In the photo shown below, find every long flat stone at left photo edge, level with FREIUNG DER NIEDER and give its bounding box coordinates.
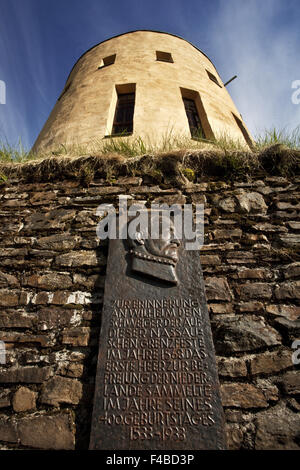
[0,367,51,383]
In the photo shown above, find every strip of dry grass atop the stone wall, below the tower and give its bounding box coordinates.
[0,127,300,186]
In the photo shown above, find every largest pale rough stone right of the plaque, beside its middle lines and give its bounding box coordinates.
[214,317,281,355]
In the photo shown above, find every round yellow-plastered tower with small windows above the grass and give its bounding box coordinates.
[33,31,252,151]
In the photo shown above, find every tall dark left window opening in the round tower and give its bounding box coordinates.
[112,93,135,135]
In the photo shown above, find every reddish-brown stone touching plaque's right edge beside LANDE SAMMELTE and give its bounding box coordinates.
[221,383,268,409]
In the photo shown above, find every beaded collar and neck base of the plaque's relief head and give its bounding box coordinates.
[130,250,178,284]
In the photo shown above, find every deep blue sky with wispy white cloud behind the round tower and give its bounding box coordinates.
[0,0,300,148]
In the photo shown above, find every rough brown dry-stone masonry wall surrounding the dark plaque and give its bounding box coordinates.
[0,172,300,449]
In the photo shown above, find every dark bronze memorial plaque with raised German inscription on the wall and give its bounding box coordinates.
[90,218,225,450]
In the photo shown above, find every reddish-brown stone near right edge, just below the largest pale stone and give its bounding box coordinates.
[249,351,293,375]
